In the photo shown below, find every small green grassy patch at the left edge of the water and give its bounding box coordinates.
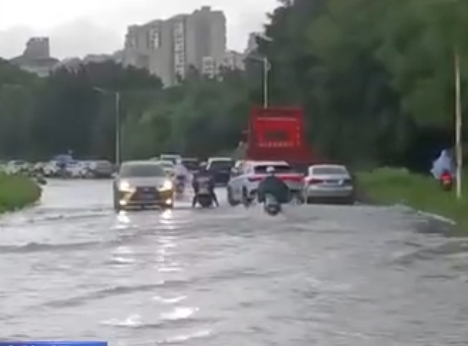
[0,172,42,213]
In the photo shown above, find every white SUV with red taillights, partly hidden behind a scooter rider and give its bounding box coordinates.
[227,161,304,206]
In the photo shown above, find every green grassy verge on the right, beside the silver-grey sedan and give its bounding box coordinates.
[357,168,468,234]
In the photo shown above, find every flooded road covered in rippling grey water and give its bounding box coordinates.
[0,181,468,346]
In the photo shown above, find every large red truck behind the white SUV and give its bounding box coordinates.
[246,107,318,170]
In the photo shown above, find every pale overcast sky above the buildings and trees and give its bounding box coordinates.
[0,0,277,58]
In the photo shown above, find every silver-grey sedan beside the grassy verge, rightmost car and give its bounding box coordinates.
[304,164,355,204]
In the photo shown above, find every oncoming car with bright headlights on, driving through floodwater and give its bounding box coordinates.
[113,161,174,211]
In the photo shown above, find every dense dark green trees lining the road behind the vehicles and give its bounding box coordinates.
[0,0,468,168]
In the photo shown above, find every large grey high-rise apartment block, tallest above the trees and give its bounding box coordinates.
[123,6,226,86]
